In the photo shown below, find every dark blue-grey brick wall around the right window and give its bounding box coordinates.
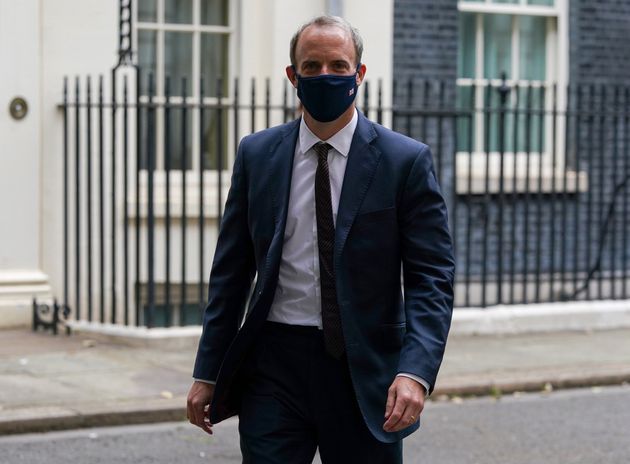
[394,0,630,304]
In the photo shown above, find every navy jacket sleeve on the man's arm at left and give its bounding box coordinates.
[193,139,255,380]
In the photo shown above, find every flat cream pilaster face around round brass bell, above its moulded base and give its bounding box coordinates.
[0,0,41,270]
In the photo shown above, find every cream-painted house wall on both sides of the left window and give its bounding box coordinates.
[0,0,393,326]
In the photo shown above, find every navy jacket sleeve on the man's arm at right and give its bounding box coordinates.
[398,146,455,392]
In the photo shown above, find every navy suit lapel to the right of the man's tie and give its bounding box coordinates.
[335,112,381,259]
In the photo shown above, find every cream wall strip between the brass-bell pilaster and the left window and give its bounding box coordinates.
[38,0,118,324]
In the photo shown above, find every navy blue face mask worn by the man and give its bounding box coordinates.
[293,63,361,122]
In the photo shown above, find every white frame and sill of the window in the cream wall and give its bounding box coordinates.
[127,0,240,220]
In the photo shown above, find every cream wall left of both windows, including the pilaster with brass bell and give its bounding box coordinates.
[0,0,118,326]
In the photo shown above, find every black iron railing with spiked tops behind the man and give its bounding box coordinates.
[62,70,630,327]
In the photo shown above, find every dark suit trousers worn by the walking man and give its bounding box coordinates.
[239,322,402,464]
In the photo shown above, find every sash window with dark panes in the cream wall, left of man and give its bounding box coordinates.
[135,0,234,170]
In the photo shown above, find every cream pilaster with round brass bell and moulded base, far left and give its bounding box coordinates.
[0,0,50,327]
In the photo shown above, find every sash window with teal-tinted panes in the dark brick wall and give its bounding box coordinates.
[457,0,560,153]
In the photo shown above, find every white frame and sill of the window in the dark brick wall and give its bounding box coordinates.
[456,0,587,193]
